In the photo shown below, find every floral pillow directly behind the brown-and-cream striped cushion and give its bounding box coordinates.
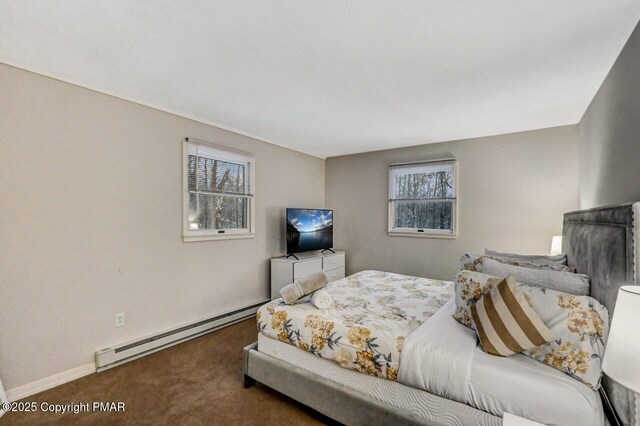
[453,271,609,390]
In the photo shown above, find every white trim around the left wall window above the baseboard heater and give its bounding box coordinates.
[182,138,256,242]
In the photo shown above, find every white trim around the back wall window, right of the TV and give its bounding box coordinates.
[387,158,460,240]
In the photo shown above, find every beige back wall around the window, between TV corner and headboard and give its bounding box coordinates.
[326,126,578,279]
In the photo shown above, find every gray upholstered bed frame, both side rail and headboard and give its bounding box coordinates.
[244,203,640,426]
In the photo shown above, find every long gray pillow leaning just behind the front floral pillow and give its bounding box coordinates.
[476,257,589,296]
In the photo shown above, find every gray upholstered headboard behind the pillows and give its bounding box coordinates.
[562,203,640,425]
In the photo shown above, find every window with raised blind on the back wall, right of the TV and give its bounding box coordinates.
[389,160,457,237]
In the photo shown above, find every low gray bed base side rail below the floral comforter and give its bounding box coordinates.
[244,342,502,426]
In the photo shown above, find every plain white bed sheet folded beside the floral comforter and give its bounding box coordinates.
[398,300,604,426]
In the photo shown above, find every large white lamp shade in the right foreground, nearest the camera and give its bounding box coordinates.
[602,285,640,392]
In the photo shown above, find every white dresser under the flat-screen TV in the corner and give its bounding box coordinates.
[271,250,344,300]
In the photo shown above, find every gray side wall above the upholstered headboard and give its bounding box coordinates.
[579,20,640,208]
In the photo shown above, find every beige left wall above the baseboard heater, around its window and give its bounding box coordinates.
[0,64,325,389]
